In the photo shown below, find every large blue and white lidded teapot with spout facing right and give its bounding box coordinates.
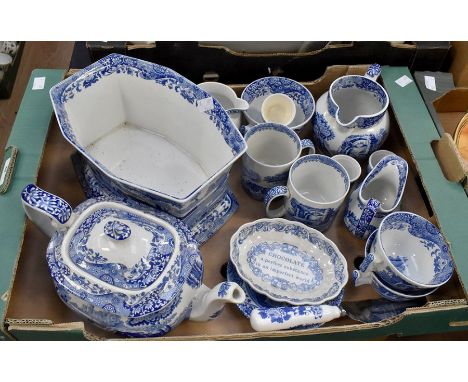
[21,184,245,336]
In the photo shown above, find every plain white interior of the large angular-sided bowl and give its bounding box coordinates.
[64,72,234,198]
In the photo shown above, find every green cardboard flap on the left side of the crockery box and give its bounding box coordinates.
[0,69,65,338]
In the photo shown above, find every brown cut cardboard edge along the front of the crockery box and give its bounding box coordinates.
[6,299,467,341]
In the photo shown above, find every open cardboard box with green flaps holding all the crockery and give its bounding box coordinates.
[0,66,468,340]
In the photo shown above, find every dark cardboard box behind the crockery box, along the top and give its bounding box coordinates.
[83,41,451,84]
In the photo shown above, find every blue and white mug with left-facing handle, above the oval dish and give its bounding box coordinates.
[264,154,350,231]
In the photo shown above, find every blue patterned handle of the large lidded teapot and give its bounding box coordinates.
[21,184,74,237]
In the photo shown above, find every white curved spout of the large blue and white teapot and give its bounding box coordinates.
[189,282,245,321]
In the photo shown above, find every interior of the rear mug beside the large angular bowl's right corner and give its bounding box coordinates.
[246,124,301,166]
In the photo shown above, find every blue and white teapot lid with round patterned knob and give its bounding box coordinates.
[61,202,180,290]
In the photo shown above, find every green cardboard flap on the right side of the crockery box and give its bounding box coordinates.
[382,66,468,296]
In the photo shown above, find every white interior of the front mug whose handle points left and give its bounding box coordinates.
[290,155,349,203]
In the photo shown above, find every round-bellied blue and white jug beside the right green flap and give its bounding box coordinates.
[312,64,390,159]
